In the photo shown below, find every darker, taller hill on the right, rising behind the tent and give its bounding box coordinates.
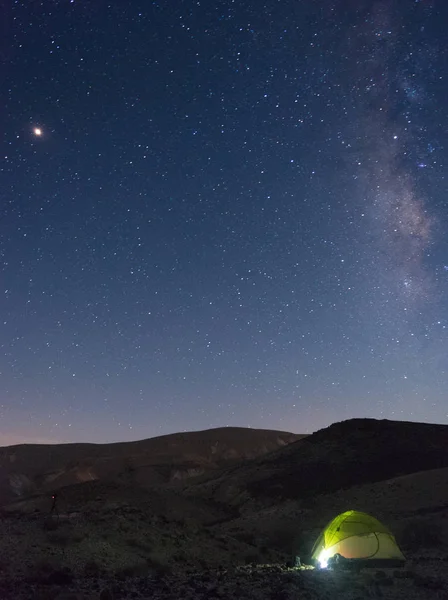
[190,419,448,505]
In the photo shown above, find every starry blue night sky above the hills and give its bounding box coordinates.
[0,0,448,444]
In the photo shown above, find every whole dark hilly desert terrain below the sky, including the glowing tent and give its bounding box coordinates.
[0,419,448,600]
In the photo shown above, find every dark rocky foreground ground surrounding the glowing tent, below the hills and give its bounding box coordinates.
[0,489,448,600]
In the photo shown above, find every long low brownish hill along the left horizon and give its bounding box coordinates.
[0,427,302,504]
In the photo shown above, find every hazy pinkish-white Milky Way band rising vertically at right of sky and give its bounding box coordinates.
[344,2,437,316]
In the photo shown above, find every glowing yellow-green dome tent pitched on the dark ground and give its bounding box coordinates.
[311,510,405,568]
